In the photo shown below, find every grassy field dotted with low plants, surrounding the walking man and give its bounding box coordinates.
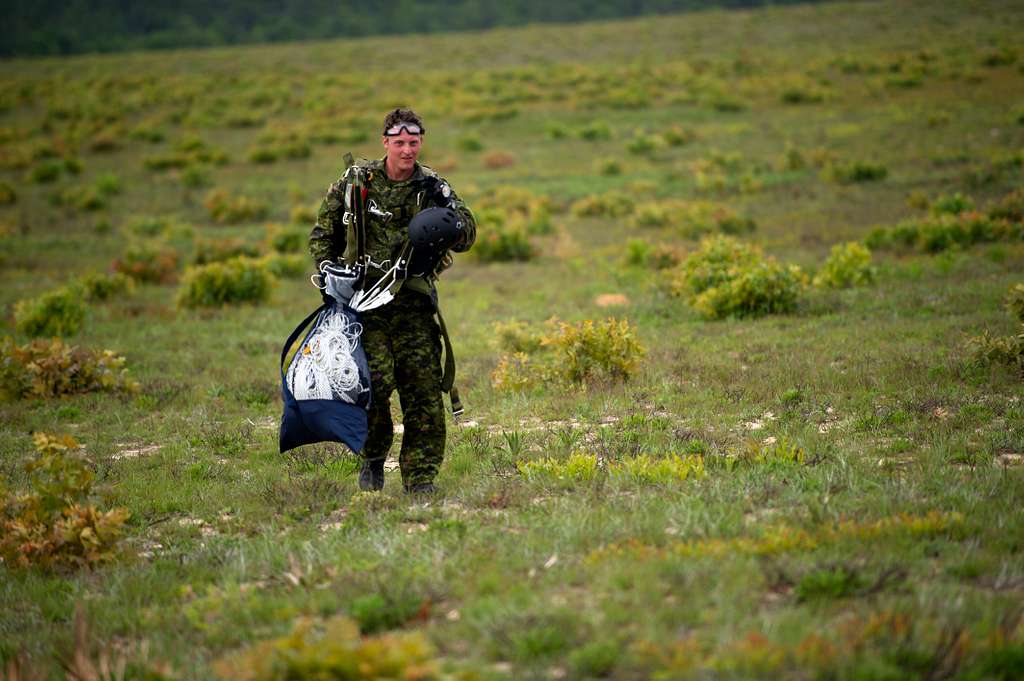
[0,1,1024,679]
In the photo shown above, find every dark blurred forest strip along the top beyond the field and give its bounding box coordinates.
[0,0,823,57]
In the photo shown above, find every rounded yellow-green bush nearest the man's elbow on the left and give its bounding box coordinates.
[177,258,271,307]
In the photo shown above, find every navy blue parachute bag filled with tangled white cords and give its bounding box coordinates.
[281,300,371,452]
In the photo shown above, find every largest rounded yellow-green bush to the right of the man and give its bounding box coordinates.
[667,237,807,320]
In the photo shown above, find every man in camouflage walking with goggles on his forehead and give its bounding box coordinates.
[309,109,476,494]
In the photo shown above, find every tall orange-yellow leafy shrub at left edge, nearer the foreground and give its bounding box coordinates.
[0,432,129,568]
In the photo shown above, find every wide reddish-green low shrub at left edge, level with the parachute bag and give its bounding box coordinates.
[0,337,138,399]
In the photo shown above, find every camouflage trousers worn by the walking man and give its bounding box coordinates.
[361,290,444,488]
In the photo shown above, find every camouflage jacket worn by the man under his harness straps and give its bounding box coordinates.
[309,159,476,293]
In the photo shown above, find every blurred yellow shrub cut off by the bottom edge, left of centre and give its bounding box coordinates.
[213,616,449,681]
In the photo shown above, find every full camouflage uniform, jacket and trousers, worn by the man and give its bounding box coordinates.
[309,159,476,488]
